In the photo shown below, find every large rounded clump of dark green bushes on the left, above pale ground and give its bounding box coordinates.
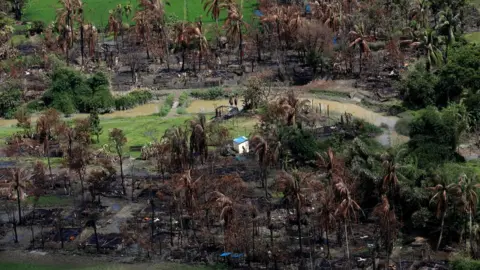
[43,68,115,114]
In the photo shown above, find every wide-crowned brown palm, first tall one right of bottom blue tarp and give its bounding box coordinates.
[275,171,311,254]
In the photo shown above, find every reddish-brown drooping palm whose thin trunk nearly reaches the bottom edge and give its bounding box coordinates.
[335,180,361,264]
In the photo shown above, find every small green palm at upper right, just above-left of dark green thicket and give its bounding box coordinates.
[410,29,442,71]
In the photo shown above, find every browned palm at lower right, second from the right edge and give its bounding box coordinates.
[427,177,458,250]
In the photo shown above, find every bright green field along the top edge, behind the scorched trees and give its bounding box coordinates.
[24,0,257,27]
